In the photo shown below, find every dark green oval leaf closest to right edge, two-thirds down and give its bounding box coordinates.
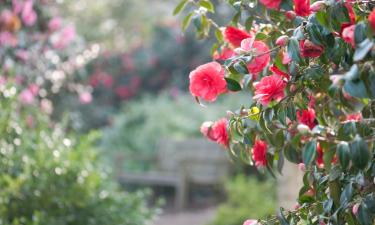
[350,135,370,170]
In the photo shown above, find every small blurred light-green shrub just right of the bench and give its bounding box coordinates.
[209,175,276,225]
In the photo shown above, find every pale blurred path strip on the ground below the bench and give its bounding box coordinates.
[154,208,216,225]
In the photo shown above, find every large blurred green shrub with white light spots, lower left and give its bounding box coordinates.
[0,87,153,225]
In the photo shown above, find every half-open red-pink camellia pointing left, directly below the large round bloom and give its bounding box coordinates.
[201,118,229,147]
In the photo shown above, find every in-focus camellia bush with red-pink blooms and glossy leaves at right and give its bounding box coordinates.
[174,0,375,225]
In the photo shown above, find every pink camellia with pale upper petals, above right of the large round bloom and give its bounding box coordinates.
[241,38,271,74]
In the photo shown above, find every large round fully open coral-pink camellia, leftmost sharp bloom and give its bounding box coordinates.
[189,62,227,102]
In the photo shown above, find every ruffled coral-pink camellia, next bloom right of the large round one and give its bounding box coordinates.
[253,75,286,105]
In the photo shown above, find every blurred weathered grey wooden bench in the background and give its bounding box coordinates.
[117,139,230,210]
